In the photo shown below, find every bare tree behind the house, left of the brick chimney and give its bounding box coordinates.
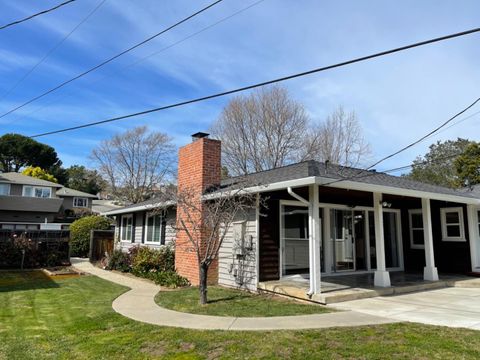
[92,126,175,203]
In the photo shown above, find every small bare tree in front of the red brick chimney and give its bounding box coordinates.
[175,184,260,305]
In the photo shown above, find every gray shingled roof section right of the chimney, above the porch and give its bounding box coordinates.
[222,160,479,199]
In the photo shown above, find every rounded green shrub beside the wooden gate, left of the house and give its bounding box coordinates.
[70,215,110,257]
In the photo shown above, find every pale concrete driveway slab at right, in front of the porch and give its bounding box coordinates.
[331,287,480,330]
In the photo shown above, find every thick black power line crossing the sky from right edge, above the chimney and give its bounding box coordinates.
[28,28,480,138]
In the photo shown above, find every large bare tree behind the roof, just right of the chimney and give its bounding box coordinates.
[211,87,309,175]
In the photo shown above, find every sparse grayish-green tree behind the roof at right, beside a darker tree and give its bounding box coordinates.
[407,138,474,188]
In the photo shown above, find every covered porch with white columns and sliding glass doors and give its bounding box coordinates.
[257,178,480,303]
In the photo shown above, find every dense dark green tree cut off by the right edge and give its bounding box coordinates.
[454,143,480,187]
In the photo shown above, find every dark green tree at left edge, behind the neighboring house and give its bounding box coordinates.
[0,134,62,172]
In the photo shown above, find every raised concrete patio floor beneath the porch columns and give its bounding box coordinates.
[258,271,480,304]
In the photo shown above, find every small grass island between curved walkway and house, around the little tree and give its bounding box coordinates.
[155,286,331,317]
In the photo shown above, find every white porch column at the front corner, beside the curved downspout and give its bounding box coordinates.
[308,185,322,295]
